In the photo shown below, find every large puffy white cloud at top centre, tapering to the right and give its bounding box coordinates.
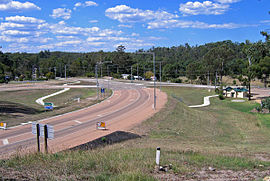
[105,5,178,23]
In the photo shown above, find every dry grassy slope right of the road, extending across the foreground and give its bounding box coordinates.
[0,88,270,180]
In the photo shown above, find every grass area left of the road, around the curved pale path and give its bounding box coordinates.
[0,88,97,127]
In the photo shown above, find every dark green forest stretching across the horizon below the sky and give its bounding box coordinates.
[0,32,270,86]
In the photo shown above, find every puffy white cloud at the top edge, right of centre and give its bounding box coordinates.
[179,1,230,15]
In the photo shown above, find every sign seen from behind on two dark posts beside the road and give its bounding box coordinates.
[32,122,54,153]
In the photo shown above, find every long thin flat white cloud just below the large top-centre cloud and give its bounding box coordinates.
[147,19,248,29]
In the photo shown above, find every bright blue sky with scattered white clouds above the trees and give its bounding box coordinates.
[0,0,270,52]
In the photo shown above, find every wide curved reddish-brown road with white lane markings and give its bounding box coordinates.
[0,80,167,157]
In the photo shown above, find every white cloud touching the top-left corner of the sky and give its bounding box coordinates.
[0,0,41,11]
